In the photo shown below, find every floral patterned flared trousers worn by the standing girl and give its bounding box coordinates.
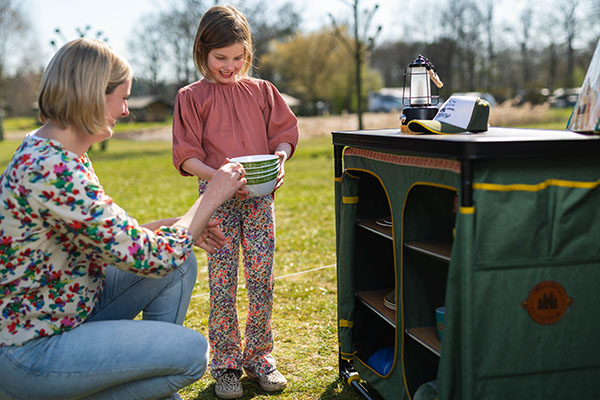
[200,182,275,378]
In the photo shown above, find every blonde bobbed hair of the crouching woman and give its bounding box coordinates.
[38,38,133,134]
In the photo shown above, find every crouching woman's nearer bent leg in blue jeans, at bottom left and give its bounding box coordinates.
[0,320,208,400]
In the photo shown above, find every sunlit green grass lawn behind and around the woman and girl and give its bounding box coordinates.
[0,114,580,400]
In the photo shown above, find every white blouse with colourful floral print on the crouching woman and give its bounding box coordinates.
[0,135,193,346]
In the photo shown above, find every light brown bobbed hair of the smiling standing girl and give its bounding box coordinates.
[194,6,254,77]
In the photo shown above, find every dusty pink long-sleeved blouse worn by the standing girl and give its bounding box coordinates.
[173,77,298,176]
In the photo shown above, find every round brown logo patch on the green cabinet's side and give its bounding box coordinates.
[521,281,573,325]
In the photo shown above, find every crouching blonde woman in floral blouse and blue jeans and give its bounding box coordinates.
[0,39,245,399]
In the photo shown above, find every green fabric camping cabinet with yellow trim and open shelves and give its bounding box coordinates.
[332,128,600,400]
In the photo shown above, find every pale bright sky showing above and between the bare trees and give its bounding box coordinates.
[23,0,580,72]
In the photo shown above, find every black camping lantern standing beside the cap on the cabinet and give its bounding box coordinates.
[401,54,441,125]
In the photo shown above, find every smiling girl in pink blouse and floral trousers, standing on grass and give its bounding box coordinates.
[173,6,298,398]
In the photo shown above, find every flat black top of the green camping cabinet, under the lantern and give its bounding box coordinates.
[332,127,600,160]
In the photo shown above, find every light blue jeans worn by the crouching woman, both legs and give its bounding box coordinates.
[0,253,208,400]
